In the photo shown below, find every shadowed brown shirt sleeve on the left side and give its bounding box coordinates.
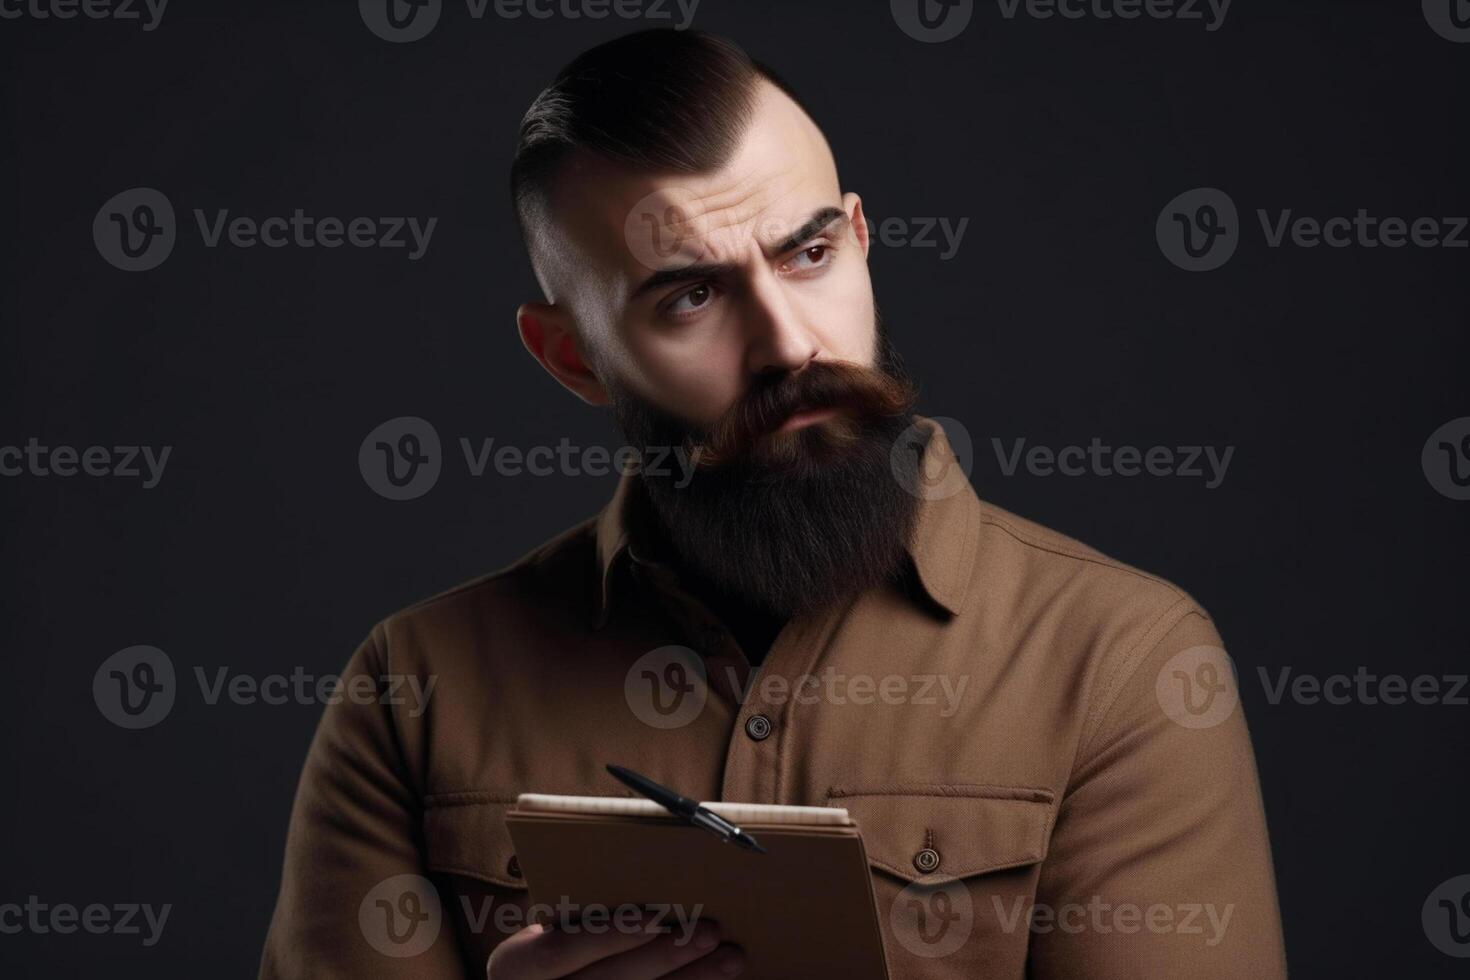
[260,627,466,980]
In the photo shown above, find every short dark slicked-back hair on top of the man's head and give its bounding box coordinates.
[510,28,801,264]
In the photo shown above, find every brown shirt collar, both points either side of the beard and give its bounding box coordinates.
[595,416,980,627]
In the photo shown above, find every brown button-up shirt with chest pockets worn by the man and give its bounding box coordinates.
[260,423,1285,980]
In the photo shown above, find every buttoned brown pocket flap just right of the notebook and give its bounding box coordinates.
[828,786,1054,883]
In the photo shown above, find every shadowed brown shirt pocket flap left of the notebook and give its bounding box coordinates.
[423,793,526,889]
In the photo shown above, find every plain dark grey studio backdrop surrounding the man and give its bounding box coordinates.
[0,0,1470,977]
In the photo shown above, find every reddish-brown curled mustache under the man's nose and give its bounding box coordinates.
[689,361,917,466]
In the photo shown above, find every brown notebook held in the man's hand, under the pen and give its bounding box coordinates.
[506,793,888,980]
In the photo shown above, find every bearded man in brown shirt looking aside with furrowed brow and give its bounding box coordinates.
[262,31,1285,980]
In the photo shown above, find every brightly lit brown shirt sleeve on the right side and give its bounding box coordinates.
[1029,601,1286,980]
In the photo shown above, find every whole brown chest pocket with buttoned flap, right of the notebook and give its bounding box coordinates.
[828,785,1055,980]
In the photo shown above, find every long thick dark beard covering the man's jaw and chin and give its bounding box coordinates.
[609,322,919,619]
